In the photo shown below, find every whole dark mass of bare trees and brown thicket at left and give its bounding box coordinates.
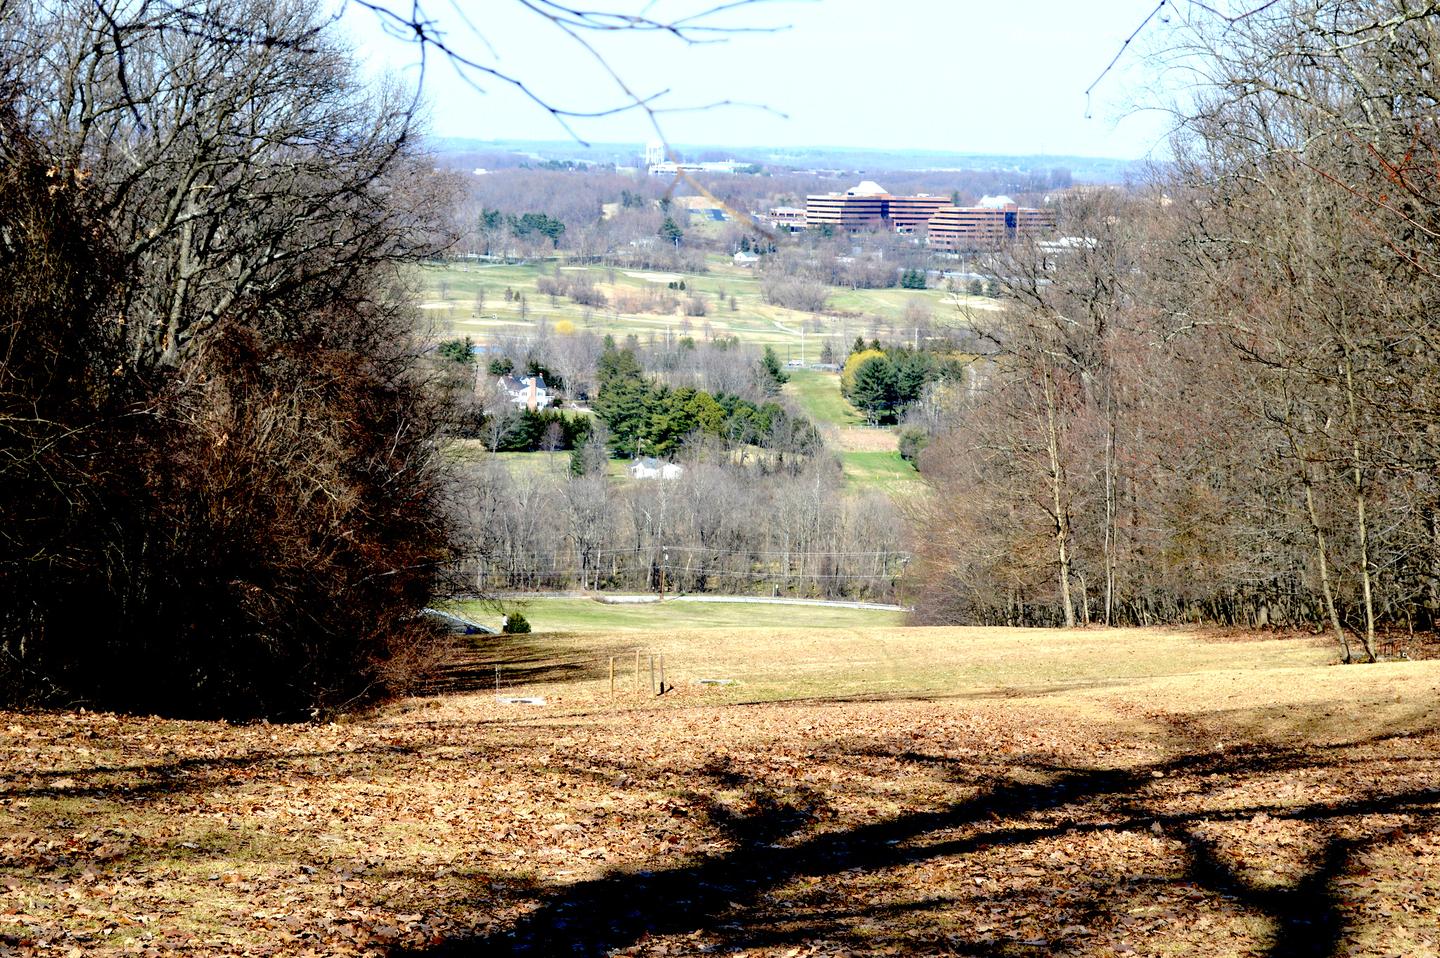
[0,0,448,716]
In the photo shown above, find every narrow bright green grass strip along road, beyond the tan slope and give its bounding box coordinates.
[454,598,904,632]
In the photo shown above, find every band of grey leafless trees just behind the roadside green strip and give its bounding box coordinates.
[458,455,906,601]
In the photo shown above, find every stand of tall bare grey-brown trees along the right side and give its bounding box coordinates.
[924,0,1440,660]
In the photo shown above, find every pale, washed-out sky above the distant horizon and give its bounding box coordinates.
[347,0,1166,158]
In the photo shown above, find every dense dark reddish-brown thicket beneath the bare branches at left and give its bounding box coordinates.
[0,29,449,719]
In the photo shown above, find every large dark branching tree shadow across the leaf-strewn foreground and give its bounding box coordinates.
[392,751,1440,958]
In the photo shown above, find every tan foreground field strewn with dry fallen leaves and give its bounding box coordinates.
[0,628,1440,958]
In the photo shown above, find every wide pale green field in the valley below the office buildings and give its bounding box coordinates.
[418,256,991,351]
